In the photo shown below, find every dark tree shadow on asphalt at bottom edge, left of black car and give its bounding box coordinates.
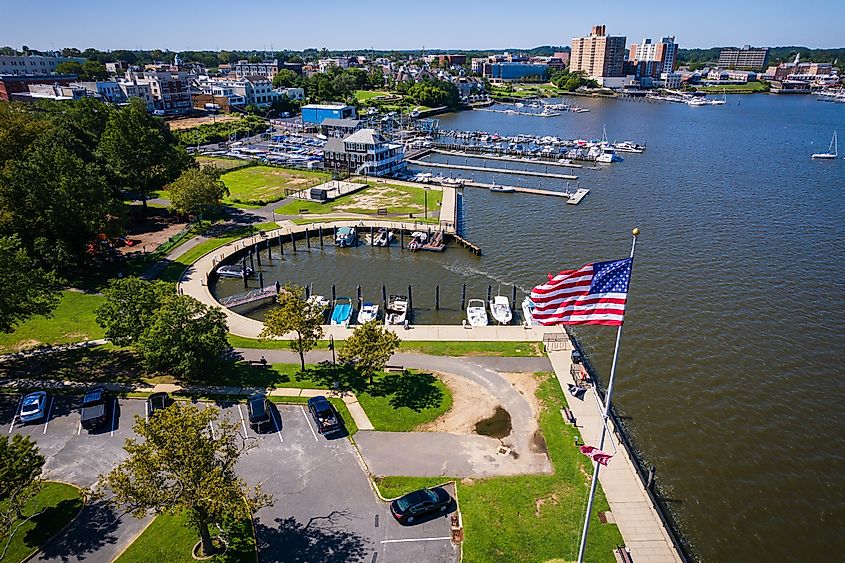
[255,511,369,563]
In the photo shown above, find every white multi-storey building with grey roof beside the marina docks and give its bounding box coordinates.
[323,129,405,176]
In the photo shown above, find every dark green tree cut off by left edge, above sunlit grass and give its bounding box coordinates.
[0,237,60,332]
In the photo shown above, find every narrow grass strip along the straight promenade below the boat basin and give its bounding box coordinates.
[229,334,544,357]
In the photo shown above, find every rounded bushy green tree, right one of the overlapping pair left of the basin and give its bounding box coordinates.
[133,294,229,379]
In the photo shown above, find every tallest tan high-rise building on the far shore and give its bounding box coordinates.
[569,25,627,85]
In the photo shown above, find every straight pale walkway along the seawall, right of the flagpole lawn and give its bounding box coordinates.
[549,351,683,563]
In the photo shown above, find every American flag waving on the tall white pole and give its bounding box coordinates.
[531,258,633,326]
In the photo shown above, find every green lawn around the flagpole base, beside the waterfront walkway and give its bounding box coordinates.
[379,374,622,563]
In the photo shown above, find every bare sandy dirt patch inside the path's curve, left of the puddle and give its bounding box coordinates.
[417,373,499,434]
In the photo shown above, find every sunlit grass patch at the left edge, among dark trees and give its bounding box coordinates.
[0,291,103,354]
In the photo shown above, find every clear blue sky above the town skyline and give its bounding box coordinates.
[6,0,845,50]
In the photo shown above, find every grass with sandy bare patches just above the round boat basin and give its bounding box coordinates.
[276,184,443,219]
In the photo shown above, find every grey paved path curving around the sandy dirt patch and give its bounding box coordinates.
[238,349,552,477]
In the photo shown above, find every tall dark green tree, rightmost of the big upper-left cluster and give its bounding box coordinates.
[98,98,192,208]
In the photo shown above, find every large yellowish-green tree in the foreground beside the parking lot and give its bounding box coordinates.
[98,405,272,556]
